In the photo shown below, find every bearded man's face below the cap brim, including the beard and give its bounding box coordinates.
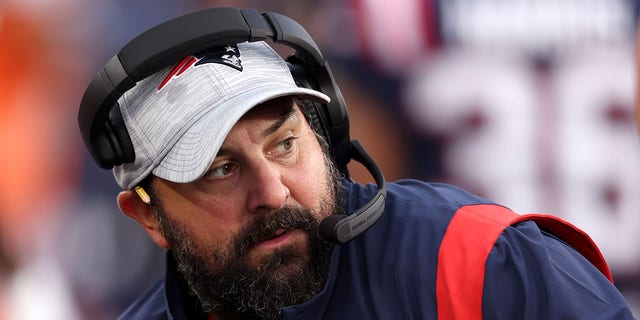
[149,99,342,318]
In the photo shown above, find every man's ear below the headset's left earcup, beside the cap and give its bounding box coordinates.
[118,190,169,249]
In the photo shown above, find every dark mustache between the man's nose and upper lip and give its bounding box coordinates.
[235,206,320,252]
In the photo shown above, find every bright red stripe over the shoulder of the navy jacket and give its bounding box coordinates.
[436,204,613,319]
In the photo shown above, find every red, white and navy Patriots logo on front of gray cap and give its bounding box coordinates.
[158,44,242,91]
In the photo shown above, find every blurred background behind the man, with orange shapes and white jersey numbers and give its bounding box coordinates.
[0,0,640,320]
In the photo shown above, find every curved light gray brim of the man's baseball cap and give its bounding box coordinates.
[153,86,330,183]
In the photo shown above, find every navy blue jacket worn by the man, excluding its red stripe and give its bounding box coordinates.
[121,180,633,320]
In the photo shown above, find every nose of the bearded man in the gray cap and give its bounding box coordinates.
[247,161,290,213]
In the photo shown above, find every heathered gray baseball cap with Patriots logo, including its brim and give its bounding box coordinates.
[113,42,329,189]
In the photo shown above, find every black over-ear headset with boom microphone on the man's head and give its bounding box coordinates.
[78,8,387,244]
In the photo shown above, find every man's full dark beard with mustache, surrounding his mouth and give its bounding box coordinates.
[156,155,344,319]
